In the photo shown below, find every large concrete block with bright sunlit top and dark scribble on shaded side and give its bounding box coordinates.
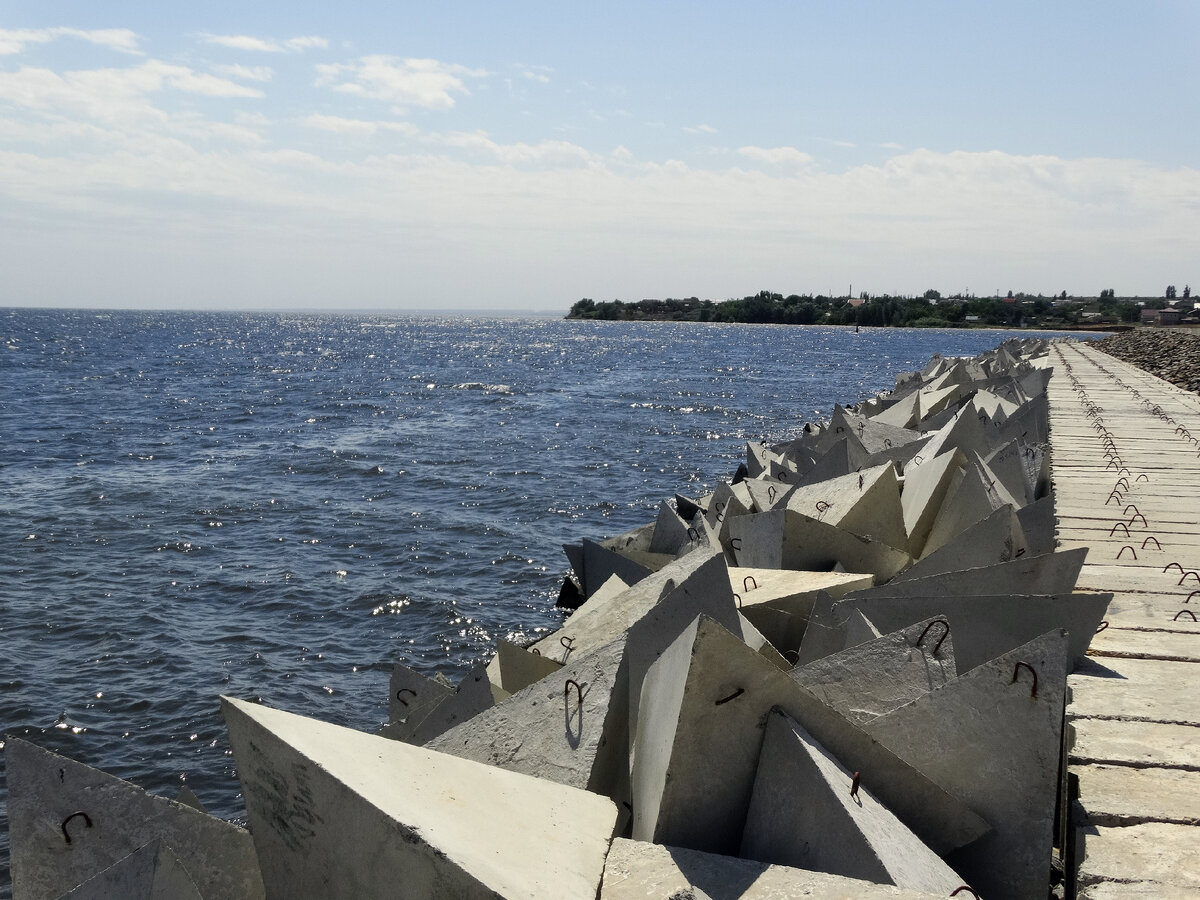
[222,697,617,900]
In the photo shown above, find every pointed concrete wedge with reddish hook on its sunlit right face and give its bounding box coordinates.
[739,709,962,896]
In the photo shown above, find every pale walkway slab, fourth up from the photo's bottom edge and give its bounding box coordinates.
[1067,719,1200,772]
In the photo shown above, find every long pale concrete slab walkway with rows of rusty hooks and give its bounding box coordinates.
[1049,342,1200,900]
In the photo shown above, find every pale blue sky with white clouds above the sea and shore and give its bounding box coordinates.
[0,0,1200,313]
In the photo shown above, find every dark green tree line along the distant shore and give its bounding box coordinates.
[566,286,1190,328]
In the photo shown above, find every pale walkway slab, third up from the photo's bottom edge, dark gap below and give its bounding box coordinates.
[1075,764,1200,826]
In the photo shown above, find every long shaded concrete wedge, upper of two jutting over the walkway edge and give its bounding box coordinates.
[847,549,1087,598]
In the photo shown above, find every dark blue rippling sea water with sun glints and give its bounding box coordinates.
[0,310,1084,893]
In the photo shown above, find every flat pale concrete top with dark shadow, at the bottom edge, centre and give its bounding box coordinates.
[600,838,943,900]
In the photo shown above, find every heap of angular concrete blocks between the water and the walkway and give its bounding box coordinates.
[8,336,1103,896]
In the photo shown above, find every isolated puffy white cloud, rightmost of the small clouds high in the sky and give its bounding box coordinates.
[317,55,487,109]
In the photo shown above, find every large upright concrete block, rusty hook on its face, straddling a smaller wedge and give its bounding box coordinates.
[632,617,986,853]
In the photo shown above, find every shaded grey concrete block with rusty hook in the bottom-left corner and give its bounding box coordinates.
[4,737,264,900]
